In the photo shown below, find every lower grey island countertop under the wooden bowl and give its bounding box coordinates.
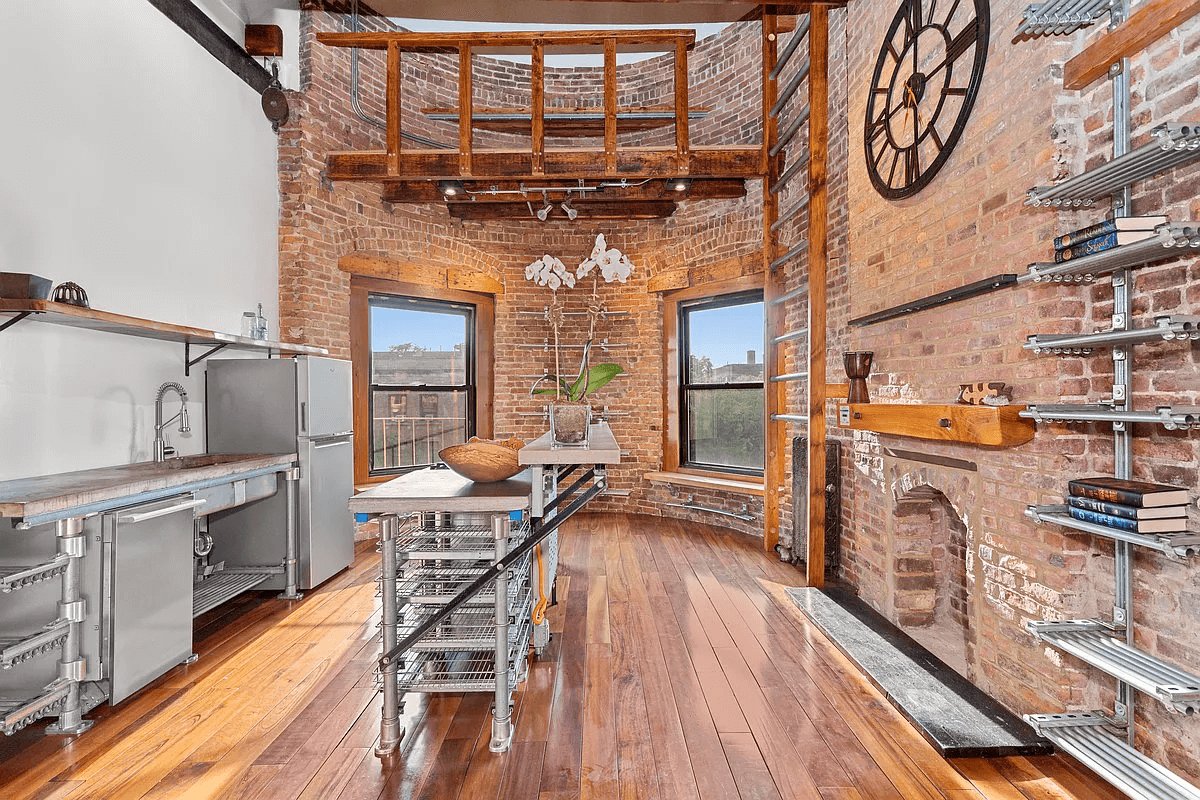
[349,468,533,513]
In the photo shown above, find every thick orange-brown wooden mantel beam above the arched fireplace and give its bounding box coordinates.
[838,403,1037,447]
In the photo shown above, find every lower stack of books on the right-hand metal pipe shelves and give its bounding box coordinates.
[1067,477,1188,534]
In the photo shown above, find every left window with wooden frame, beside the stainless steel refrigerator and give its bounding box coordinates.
[350,276,492,481]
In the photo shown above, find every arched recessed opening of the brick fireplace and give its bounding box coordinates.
[893,486,974,680]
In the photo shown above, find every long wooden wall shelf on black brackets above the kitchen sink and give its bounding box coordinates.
[0,299,329,374]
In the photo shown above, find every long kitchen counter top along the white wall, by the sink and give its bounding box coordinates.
[0,453,296,528]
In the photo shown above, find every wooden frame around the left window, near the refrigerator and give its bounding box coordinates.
[350,275,496,486]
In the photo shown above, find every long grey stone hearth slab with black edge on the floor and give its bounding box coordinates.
[787,587,1054,758]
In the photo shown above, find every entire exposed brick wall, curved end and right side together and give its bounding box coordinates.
[280,0,1200,776]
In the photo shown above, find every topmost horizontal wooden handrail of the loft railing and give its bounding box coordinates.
[314,28,696,54]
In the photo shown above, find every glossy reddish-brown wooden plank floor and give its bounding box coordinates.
[0,515,1123,800]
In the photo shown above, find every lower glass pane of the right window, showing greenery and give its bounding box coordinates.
[688,389,766,470]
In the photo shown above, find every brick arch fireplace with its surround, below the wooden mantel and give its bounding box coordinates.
[883,451,983,680]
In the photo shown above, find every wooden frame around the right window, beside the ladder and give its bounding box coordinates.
[662,273,766,480]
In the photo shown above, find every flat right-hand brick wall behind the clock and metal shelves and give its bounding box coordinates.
[830,0,1200,776]
